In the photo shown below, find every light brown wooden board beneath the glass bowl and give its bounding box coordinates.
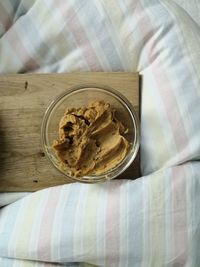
[0,72,140,192]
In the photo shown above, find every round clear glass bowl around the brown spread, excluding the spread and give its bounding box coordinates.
[41,84,139,183]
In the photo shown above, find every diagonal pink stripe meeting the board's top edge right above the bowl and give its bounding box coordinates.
[55,1,103,71]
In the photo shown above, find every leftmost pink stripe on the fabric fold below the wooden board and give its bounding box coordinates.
[37,186,62,261]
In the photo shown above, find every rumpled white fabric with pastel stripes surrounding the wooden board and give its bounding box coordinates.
[0,0,200,267]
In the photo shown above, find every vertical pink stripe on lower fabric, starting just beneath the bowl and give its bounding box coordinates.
[105,181,122,267]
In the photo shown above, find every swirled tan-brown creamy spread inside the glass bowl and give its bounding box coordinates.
[53,101,130,177]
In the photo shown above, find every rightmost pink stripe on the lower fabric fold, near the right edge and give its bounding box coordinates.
[172,166,188,266]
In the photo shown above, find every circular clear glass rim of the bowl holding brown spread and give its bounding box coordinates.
[41,83,140,183]
